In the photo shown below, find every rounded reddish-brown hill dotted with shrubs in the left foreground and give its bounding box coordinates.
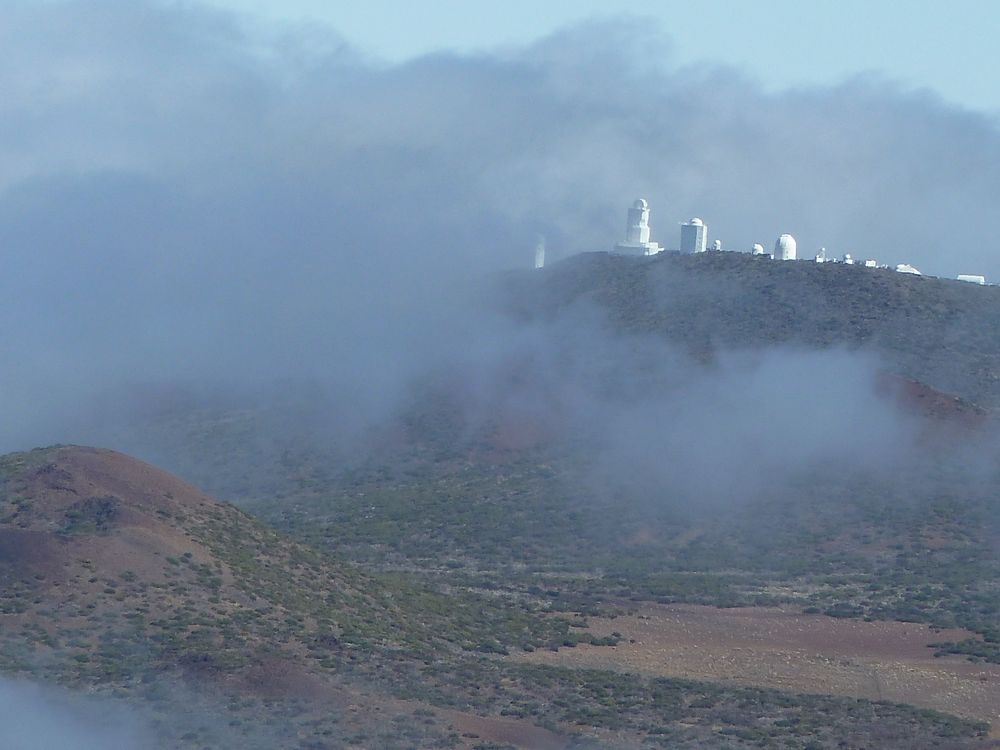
[0,447,410,747]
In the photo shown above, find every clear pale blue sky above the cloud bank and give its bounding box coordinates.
[203,0,1000,113]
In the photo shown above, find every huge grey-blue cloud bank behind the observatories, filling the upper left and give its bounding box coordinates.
[0,0,1000,458]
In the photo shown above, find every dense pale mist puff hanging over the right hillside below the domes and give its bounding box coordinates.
[599,350,917,508]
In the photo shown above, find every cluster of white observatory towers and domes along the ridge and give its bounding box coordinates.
[596,198,986,284]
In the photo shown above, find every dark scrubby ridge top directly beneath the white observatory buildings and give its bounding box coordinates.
[504,252,1000,410]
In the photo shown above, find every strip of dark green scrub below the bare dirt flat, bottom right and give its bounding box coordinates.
[420,661,988,748]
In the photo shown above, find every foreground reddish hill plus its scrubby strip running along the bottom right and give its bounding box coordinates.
[0,447,989,750]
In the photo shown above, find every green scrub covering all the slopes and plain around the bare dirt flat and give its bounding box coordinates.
[0,254,1000,748]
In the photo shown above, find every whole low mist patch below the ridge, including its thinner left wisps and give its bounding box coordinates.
[434,306,922,509]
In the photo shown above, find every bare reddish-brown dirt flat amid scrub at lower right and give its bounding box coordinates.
[511,605,1000,737]
